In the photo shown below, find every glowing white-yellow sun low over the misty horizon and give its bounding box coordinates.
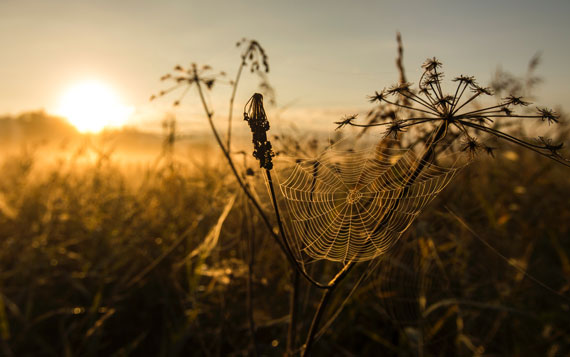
[56,81,133,133]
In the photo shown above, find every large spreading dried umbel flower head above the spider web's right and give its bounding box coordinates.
[336,58,570,167]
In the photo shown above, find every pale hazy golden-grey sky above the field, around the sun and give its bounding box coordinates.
[0,0,570,132]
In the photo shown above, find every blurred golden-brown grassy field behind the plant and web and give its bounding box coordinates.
[0,113,570,356]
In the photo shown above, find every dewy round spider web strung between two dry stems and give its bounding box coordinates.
[279,140,458,263]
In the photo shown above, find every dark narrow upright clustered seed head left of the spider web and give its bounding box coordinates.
[243,93,275,170]
